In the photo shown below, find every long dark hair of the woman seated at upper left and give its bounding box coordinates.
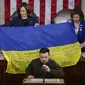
[17,2,31,17]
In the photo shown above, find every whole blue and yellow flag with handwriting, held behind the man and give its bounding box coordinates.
[0,23,81,74]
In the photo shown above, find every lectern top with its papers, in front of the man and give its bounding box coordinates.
[22,79,64,85]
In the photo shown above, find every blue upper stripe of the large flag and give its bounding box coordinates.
[0,23,78,51]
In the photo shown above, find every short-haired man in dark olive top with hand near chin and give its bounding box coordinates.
[26,48,64,79]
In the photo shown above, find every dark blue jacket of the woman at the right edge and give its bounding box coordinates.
[73,21,85,52]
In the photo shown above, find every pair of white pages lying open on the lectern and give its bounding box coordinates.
[23,79,64,84]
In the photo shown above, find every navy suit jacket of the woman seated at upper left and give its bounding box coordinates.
[5,16,38,27]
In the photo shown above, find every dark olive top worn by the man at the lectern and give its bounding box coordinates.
[26,58,64,78]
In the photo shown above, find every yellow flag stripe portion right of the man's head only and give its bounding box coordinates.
[51,42,81,67]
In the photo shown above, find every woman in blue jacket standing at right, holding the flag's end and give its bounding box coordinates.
[71,8,85,52]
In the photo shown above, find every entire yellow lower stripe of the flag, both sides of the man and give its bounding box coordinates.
[2,42,81,74]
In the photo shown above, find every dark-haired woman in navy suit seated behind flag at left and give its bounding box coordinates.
[7,2,38,27]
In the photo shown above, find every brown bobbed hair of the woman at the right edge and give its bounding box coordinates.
[71,8,84,22]
